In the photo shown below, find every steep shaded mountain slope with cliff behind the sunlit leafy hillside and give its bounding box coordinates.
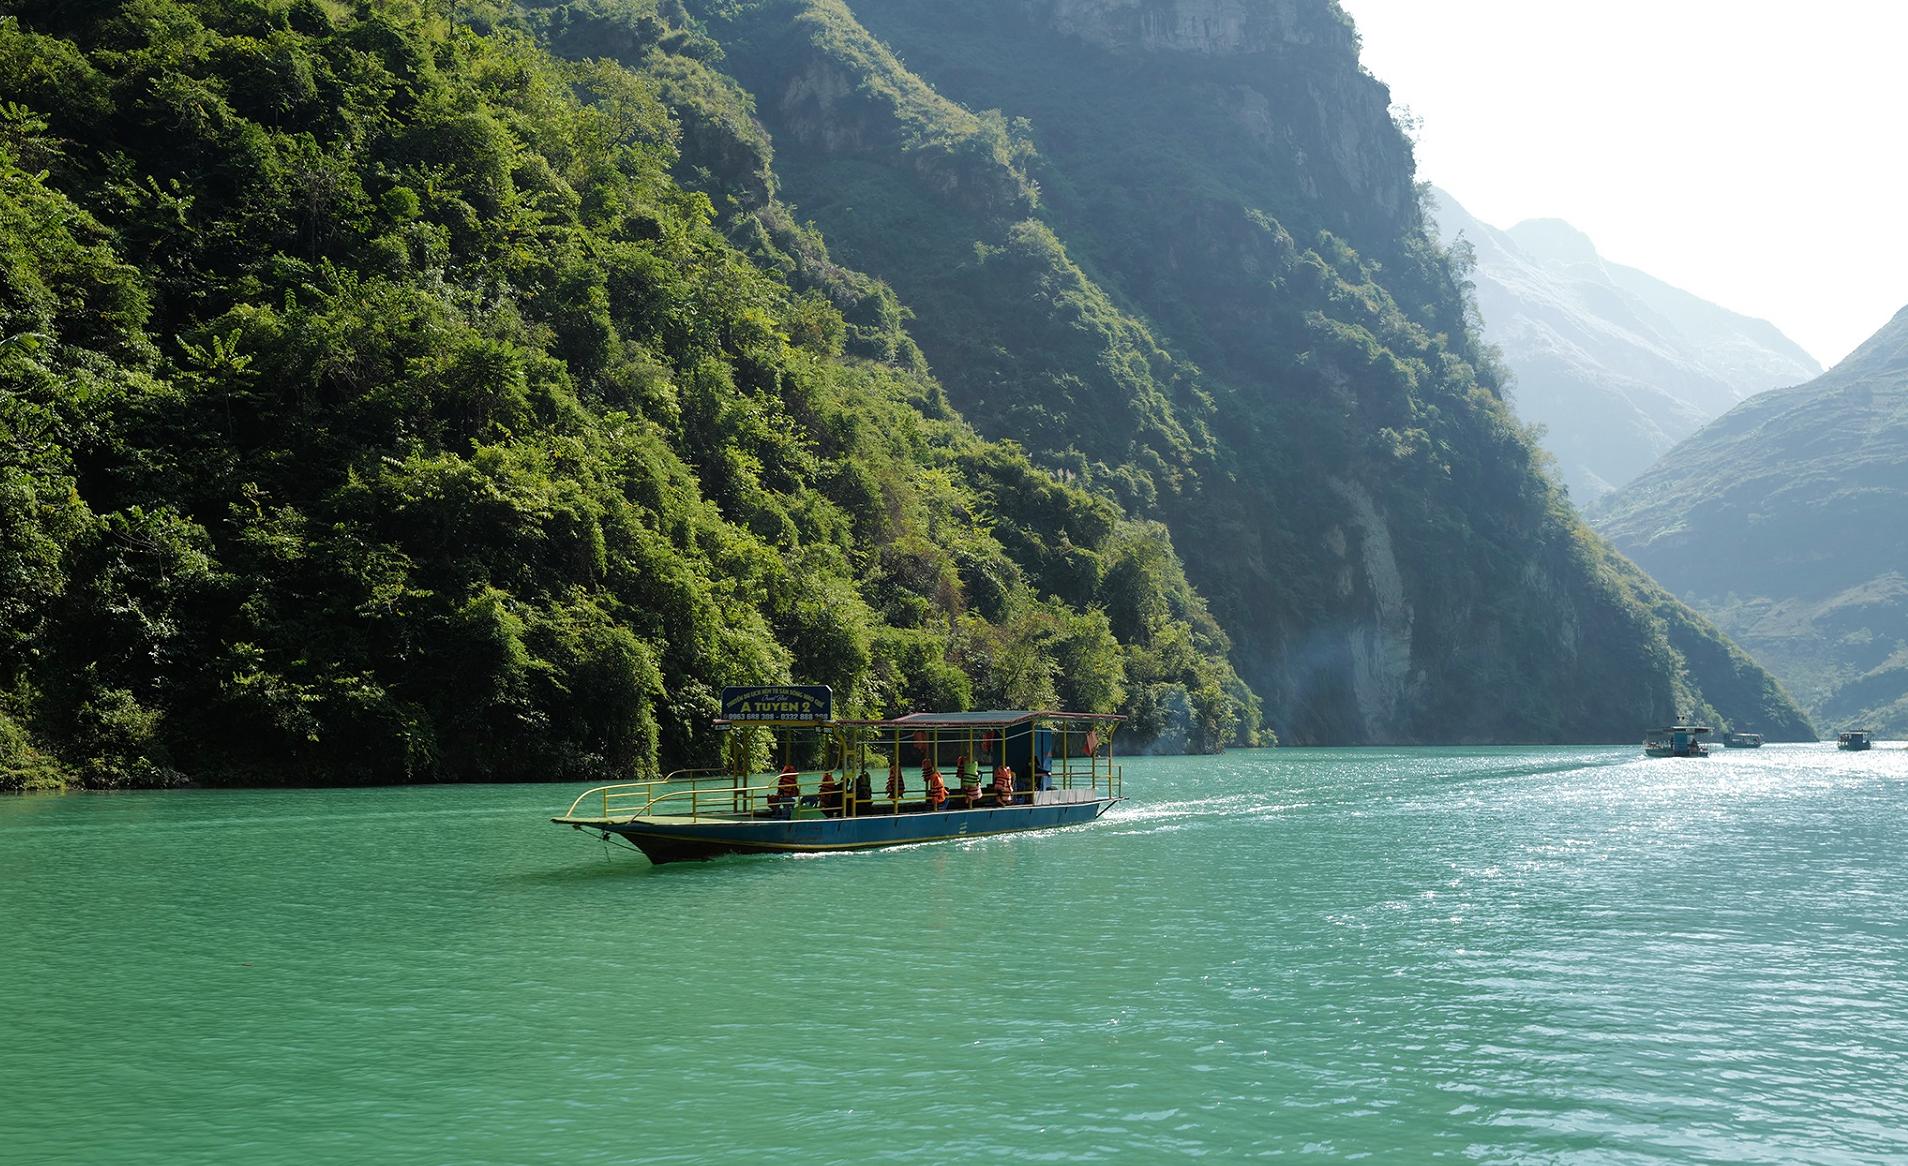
[663,0,1809,742]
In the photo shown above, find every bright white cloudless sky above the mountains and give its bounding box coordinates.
[1341,0,1908,366]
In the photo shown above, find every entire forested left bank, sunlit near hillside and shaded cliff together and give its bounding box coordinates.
[0,0,1801,784]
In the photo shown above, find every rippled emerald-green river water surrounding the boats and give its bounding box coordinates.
[0,746,1908,1164]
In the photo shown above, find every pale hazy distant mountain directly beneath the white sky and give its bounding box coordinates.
[1435,191,1820,502]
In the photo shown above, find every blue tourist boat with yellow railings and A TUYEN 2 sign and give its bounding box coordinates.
[551,685,1124,864]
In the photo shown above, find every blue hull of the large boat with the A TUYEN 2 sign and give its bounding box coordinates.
[580,798,1116,864]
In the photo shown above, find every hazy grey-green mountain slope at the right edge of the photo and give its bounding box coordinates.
[1597,309,1908,735]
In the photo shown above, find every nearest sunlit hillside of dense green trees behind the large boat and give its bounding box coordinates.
[0,0,1257,784]
